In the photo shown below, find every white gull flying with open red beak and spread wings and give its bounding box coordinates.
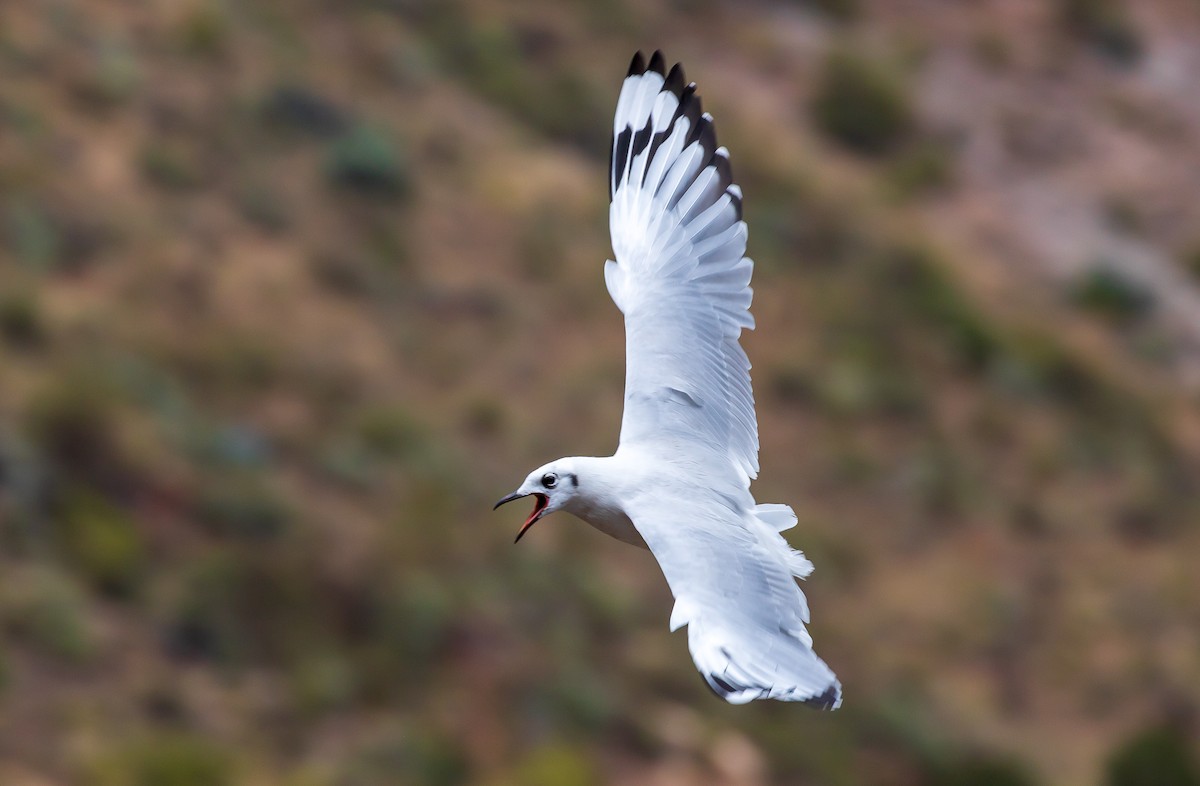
[496,52,841,709]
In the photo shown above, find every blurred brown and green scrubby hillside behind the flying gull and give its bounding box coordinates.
[0,0,1200,786]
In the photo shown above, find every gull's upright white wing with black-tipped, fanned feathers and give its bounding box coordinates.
[605,52,758,487]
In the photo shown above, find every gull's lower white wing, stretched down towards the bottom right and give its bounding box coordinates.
[625,492,841,709]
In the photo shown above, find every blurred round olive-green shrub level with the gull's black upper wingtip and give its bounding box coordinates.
[812,49,913,155]
